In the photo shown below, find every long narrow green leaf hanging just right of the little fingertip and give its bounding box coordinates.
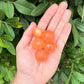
[72,25,79,46]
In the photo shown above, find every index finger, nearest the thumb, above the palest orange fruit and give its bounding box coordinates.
[38,4,58,30]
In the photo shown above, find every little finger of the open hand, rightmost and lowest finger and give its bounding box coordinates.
[56,23,71,52]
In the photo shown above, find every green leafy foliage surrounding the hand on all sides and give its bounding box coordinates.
[0,0,84,84]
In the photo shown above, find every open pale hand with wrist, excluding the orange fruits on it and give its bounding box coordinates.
[12,2,71,84]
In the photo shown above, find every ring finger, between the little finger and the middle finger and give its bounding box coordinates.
[55,9,71,41]
